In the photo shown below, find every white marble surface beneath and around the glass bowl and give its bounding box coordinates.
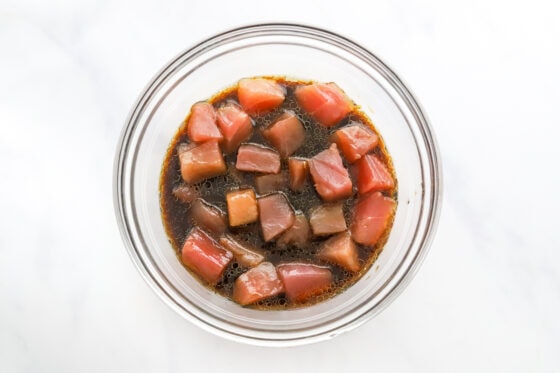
[0,0,560,372]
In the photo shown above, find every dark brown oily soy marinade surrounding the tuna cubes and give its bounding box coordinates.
[160,77,397,309]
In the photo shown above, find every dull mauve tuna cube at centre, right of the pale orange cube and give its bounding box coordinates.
[258,193,295,241]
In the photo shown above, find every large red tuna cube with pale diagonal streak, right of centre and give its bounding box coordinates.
[309,144,352,201]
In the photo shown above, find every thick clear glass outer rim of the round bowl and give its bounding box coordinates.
[113,23,443,346]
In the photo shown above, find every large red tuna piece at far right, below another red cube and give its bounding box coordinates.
[350,192,396,246]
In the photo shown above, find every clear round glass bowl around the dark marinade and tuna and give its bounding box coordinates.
[114,24,442,346]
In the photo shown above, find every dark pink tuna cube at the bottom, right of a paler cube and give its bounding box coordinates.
[276,263,332,302]
